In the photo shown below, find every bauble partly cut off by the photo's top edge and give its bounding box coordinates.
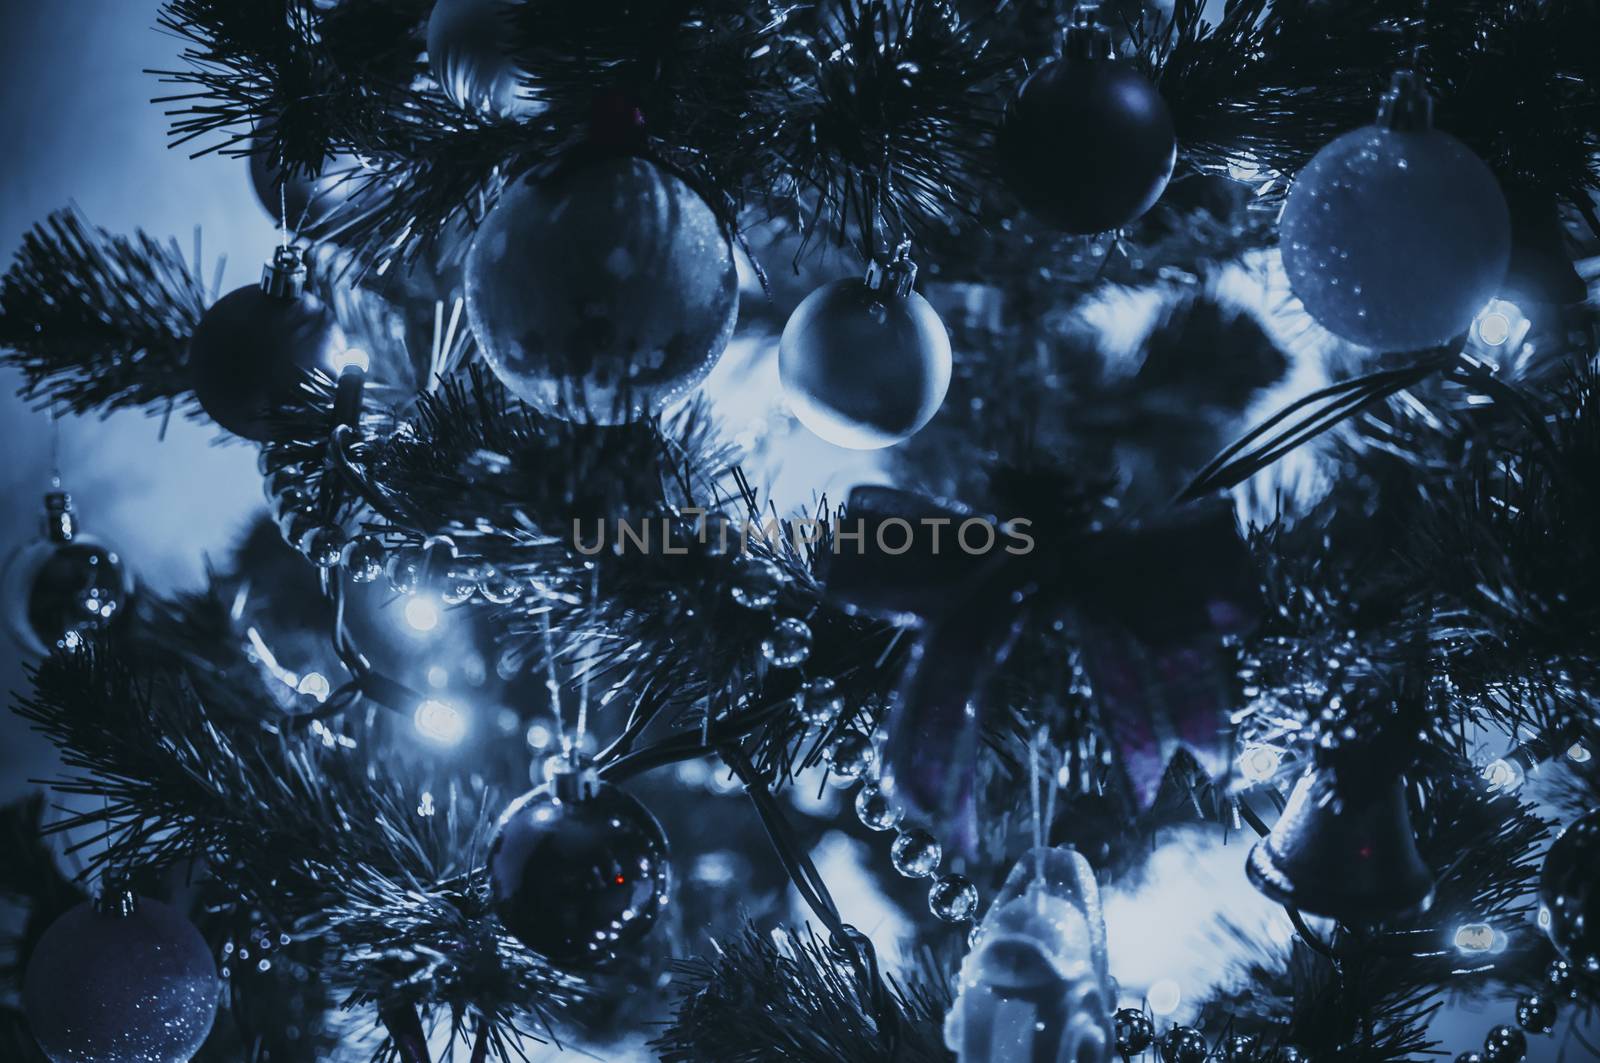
[427,0,544,120]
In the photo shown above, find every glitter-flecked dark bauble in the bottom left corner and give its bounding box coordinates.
[22,897,219,1063]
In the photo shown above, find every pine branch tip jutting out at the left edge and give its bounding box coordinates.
[0,210,208,413]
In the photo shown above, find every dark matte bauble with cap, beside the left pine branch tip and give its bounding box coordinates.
[189,248,346,442]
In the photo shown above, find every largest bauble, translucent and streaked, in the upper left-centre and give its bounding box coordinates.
[466,158,739,424]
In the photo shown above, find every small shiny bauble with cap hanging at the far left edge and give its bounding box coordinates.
[0,491,133,653]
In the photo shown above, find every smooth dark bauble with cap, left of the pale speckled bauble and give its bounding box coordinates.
[998,8,1178,232]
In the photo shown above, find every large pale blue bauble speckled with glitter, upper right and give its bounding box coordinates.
[1278,125,1510,351]
